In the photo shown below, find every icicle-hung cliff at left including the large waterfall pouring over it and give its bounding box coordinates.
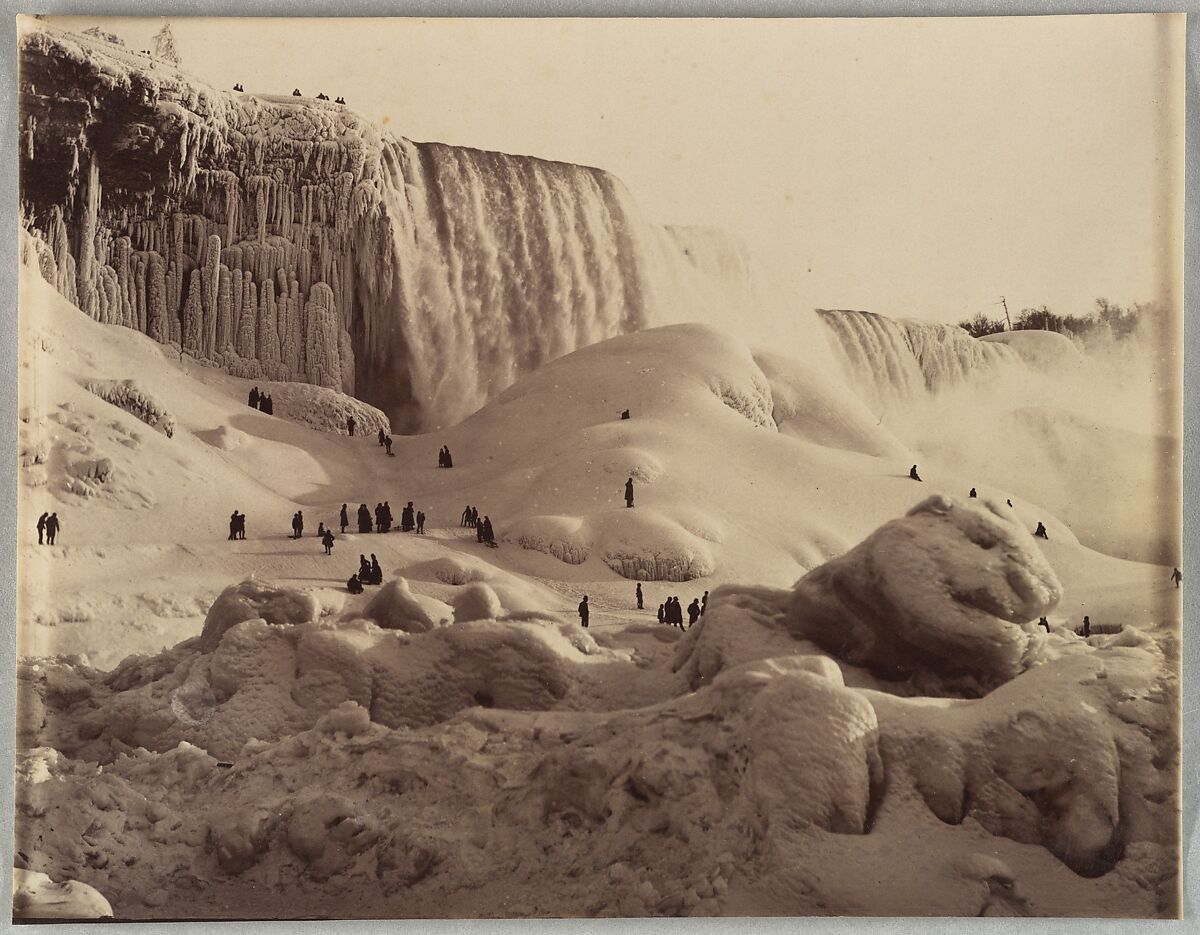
[20,23,749,431]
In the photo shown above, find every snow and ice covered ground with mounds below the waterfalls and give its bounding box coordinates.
[17,259,1180,918]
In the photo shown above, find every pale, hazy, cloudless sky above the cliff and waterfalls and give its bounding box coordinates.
[46,16,1183,320]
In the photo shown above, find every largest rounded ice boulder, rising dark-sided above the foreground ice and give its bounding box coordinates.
[788,496,1062,694]
